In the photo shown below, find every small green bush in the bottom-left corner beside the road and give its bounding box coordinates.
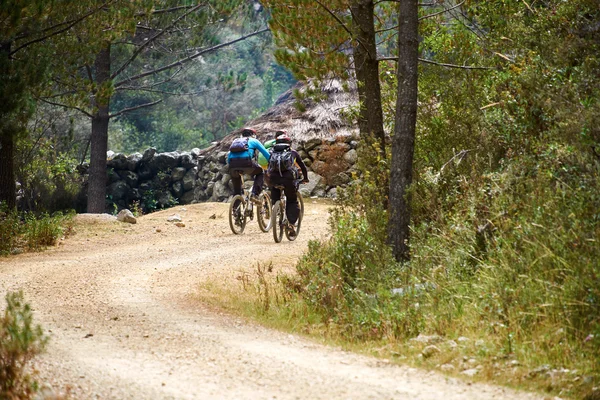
[0,292,48,400]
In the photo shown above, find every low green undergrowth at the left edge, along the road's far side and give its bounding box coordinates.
[0,203,74,255]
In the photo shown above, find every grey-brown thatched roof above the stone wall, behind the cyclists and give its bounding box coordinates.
[207,80,358,151]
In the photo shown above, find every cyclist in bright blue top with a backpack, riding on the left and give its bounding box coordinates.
[227,128,270,202]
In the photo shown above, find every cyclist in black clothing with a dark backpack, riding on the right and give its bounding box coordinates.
[267,131,308,236]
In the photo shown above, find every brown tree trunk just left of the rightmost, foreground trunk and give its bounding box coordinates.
[350,0,385,159]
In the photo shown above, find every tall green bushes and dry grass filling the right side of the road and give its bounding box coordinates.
[198,0,600,399]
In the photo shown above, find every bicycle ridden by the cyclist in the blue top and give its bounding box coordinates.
[229,171,271,235]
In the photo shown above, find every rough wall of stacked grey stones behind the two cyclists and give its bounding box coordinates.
[107,136,357,210]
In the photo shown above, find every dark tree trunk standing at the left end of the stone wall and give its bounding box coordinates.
[87,44,110,214]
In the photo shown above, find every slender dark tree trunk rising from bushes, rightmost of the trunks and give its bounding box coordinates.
[388,0,419,261]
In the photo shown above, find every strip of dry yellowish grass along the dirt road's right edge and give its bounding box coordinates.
[198,264,598,399]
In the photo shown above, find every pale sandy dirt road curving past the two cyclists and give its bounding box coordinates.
[0,201,541,400]
